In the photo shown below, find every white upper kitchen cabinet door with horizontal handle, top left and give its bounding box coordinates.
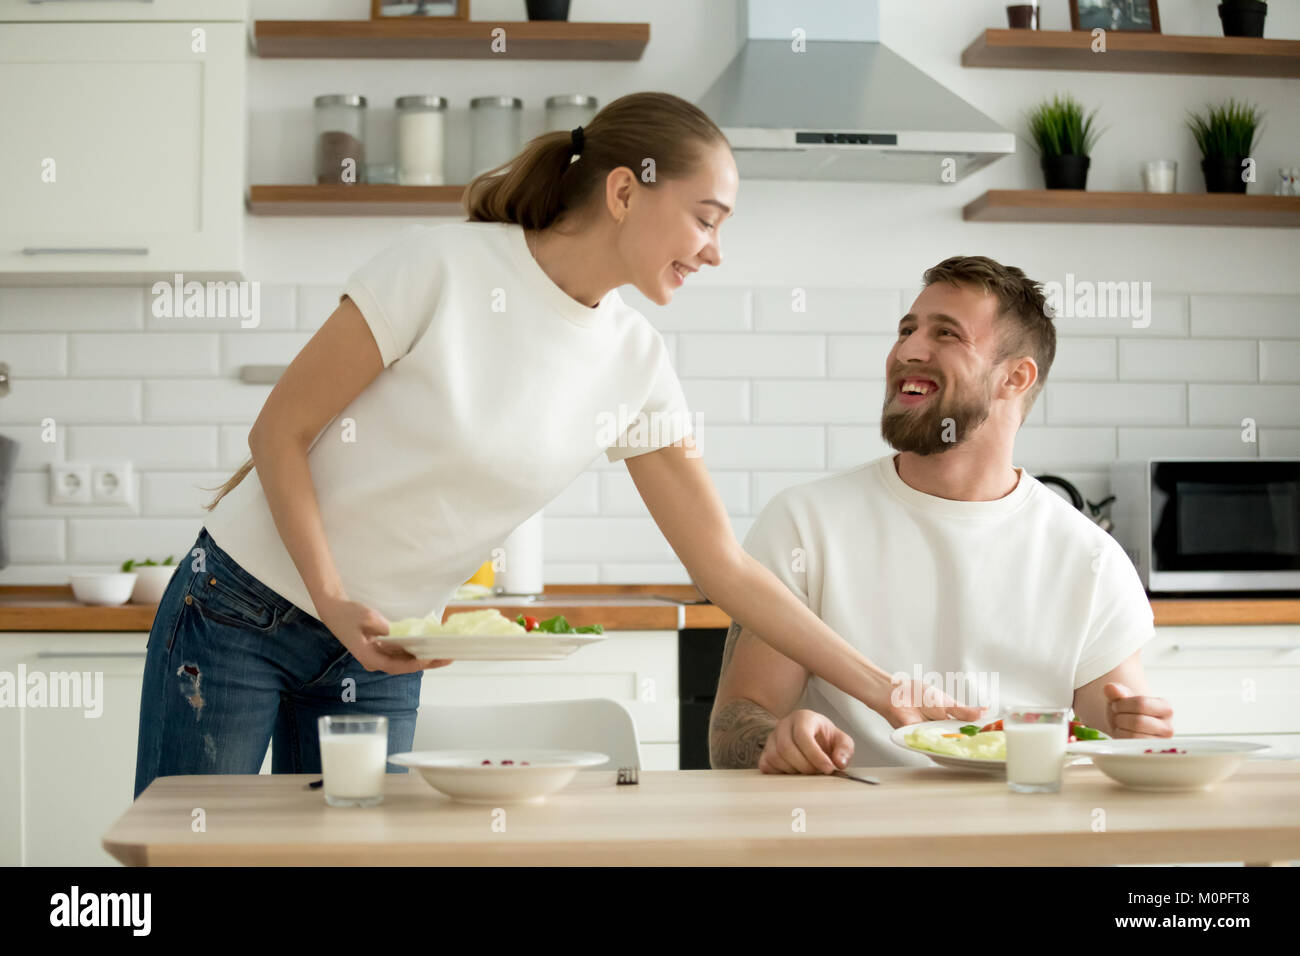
[0,14,247,285]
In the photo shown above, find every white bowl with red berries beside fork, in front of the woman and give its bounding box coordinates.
[389,747,610,805]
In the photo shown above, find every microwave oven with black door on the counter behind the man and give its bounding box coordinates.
[1110,458,1300,593]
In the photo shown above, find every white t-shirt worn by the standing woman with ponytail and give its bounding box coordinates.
[204,222,692,620]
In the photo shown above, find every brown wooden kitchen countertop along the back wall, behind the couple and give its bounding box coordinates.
[0,584,1300,632]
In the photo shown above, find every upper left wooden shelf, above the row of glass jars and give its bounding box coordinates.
[254,17,650,60]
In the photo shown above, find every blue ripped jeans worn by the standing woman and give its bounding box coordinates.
[135,528,424,797]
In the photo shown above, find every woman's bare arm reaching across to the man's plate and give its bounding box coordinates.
[624,445,980,727]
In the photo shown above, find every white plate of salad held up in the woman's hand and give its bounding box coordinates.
[376,607,605,661]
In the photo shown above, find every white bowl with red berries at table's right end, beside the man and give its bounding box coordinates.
[1066,736,1269,791]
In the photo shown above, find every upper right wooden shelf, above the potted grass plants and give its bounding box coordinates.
[962,30,1300,77]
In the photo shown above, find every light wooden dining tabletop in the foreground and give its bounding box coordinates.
[104,761,1300,866]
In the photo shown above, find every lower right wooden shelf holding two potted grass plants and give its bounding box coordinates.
[962,189,1300,229]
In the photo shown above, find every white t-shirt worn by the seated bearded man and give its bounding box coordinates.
[745,455,1154,766]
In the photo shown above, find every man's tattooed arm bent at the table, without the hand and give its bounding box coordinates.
[709,620,809,770]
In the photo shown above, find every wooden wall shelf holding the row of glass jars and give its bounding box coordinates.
[244,183,465,216]
